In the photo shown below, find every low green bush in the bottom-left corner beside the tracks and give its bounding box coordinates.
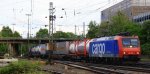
[0,61,39,74]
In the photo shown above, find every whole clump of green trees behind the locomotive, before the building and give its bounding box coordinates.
[87,12,141,38]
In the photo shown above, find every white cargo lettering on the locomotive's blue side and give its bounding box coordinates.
[92,43,105,57]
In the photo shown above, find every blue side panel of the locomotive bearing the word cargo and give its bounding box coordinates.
[89,40,119,57]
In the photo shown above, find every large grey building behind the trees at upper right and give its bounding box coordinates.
[101,0,150,22]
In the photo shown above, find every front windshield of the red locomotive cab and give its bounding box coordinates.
[122,38,138,48]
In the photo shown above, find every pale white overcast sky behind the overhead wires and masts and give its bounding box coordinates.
[0,0,122,38]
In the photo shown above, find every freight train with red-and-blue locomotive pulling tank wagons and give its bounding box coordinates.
[31,36,141,62]
